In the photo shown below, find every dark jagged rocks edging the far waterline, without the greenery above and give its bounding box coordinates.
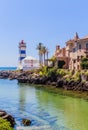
[0,71,88,92]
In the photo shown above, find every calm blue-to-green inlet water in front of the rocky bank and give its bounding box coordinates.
[0,79,88,130]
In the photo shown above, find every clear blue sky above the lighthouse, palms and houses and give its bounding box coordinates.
[0,0,88,66]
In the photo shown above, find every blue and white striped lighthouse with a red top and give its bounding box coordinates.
[19,40,26,65]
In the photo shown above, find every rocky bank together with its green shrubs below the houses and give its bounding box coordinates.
[0,66,88,91]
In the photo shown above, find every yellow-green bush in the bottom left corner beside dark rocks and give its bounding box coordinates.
[0,118,14,130]
